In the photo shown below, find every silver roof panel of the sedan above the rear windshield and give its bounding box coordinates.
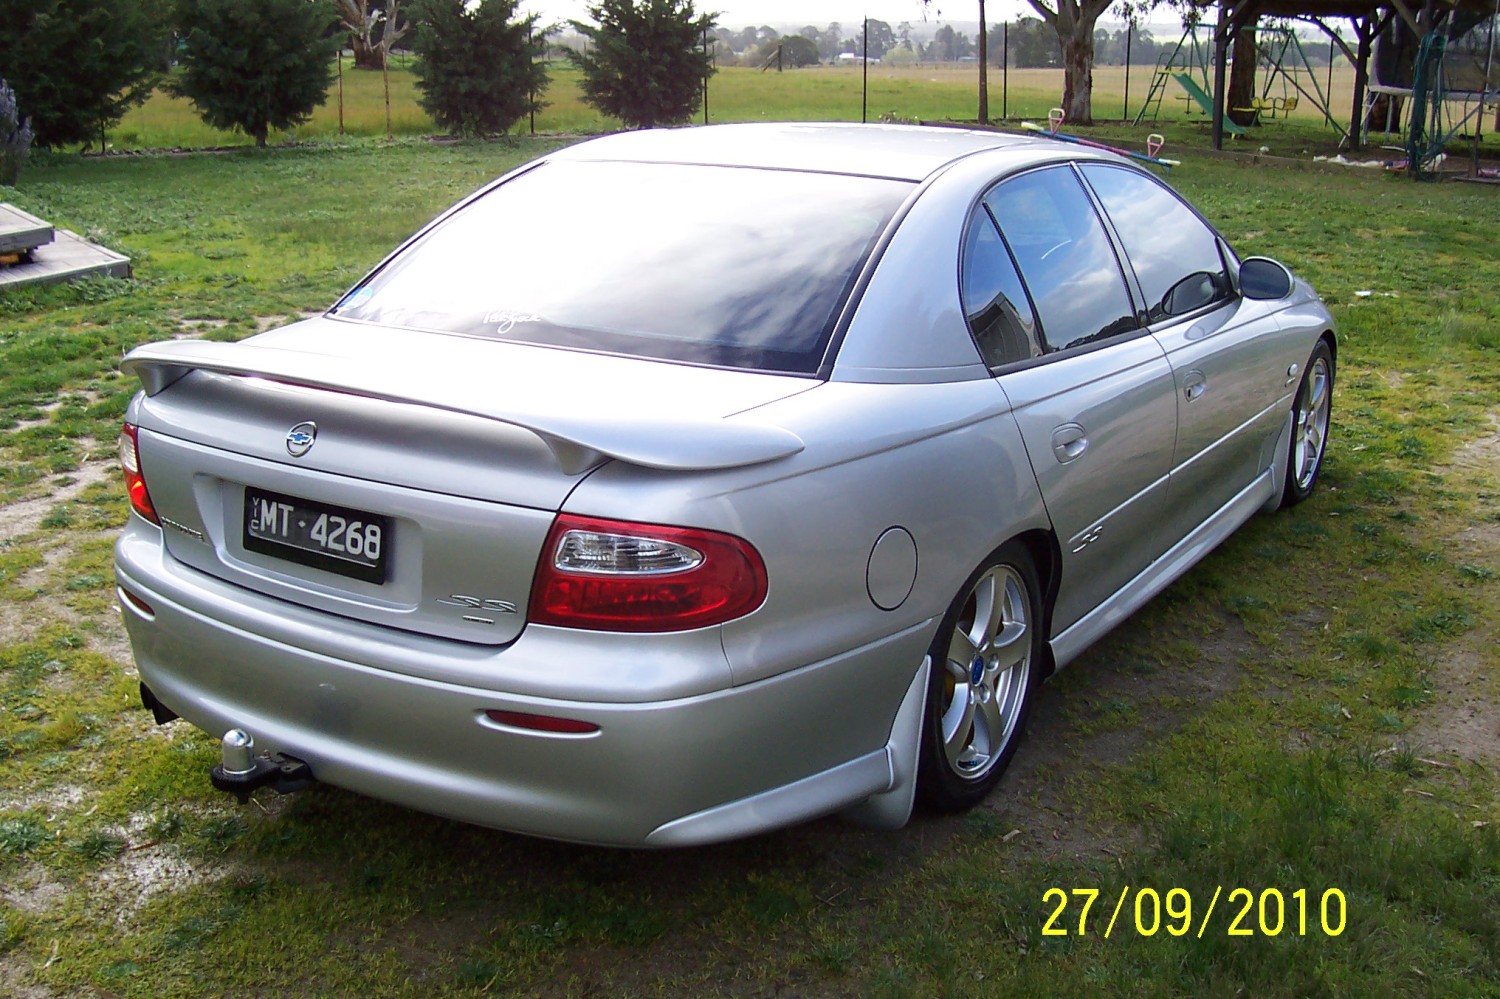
[549,122,1055,182]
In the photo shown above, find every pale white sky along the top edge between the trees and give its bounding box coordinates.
[516,0,1031,32]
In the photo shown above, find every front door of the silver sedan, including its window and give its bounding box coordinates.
[1080,164,1286,542]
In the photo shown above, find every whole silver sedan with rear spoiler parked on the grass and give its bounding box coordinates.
[117,125,1335,846]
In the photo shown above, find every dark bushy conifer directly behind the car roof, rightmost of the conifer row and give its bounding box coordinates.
[569,0,716,129]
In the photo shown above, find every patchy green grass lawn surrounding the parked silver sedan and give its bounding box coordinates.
[0,130,1500,998]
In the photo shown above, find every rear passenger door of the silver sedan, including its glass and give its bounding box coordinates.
[963,165,1176,635]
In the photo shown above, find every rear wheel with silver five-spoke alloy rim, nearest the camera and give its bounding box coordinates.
[917,542,1043,812]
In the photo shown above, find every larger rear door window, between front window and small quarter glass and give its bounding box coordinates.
[984,167,1139,351]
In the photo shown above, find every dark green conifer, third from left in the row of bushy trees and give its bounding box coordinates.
[414,0,548,135]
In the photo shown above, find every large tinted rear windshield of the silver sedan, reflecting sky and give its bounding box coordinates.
[333,162,912,372]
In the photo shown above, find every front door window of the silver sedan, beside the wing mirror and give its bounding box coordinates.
[1083,164,1232,323]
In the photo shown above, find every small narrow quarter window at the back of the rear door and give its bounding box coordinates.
[959,206,1041,369]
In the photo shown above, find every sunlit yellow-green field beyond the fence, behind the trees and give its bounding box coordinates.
[110,59,1380,150]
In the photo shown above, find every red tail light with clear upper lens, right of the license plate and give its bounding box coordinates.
[528,513,767,632]
